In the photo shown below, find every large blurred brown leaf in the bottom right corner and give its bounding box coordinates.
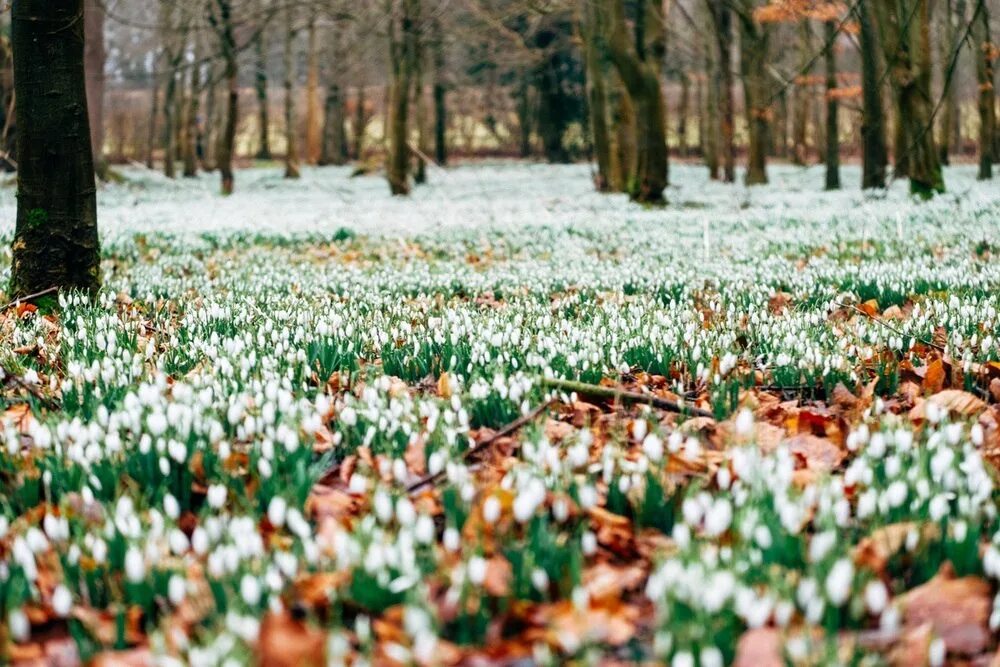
[899,563,993,656]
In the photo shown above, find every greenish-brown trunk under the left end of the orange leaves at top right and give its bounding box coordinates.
[738,10,771,185]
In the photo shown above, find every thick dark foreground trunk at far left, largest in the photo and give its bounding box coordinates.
[8,0,101,297]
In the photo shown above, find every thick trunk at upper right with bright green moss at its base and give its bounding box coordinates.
[875,0,944,198]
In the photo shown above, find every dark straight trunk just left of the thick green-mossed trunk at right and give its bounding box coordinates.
[857,0,888,189]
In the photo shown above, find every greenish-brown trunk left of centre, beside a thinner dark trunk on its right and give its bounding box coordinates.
[386,0,419,195]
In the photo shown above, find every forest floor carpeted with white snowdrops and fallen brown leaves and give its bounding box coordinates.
[0,164,1000,667]
